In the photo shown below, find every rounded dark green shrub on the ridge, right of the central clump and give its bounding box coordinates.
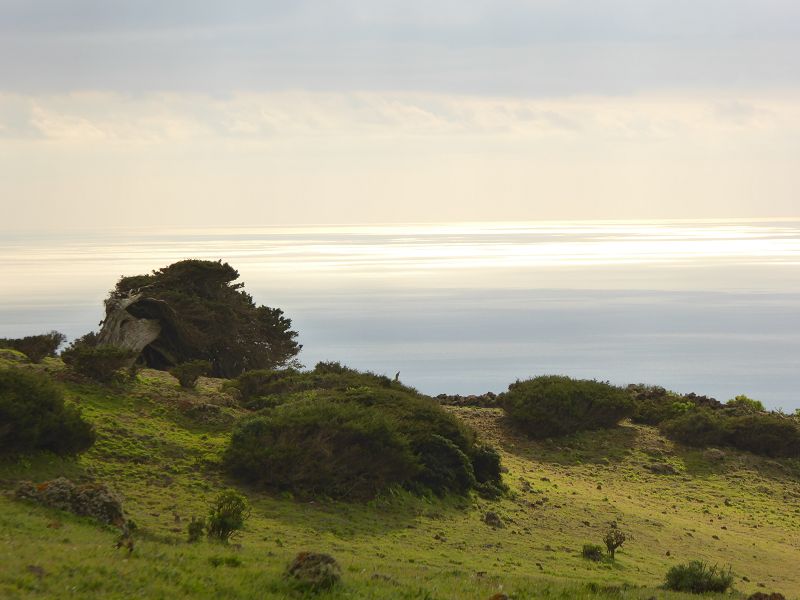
[502,375,633,438]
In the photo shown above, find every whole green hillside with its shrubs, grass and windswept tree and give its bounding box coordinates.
[0,261,800,600]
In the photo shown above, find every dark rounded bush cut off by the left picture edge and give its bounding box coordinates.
[0,369,95,454]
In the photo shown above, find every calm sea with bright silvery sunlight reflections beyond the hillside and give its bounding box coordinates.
[0,220,800,410]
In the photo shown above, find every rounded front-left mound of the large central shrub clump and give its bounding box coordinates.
[225,399,420,499]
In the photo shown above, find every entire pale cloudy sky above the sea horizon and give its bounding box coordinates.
[0,0,800,230]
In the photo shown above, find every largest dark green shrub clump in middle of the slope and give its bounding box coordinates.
[225,363,504,499]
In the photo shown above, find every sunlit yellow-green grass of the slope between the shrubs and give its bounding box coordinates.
[0,361,800,599]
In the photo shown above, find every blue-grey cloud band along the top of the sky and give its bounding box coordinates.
[0,0,800,96]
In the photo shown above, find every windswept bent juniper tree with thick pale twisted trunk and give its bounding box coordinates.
[91,260,302,377]
